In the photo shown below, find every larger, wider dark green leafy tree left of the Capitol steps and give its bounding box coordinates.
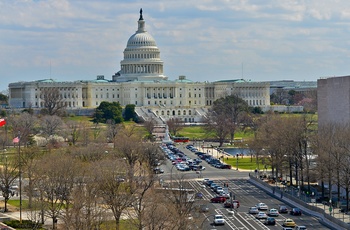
[93,101,123,124]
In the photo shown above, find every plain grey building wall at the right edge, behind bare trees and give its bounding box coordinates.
[317,76,350,125]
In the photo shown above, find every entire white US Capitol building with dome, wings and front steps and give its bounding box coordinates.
[9,10,270,122]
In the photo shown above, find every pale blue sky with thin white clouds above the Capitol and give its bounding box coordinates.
[0,0,350,90]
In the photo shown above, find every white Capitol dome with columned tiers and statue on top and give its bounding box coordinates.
[113,9,167,82]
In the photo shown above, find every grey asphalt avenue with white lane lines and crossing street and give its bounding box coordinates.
[161,143,329,230]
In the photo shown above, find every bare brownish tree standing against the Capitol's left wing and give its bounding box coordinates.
[40,87,67,116]
